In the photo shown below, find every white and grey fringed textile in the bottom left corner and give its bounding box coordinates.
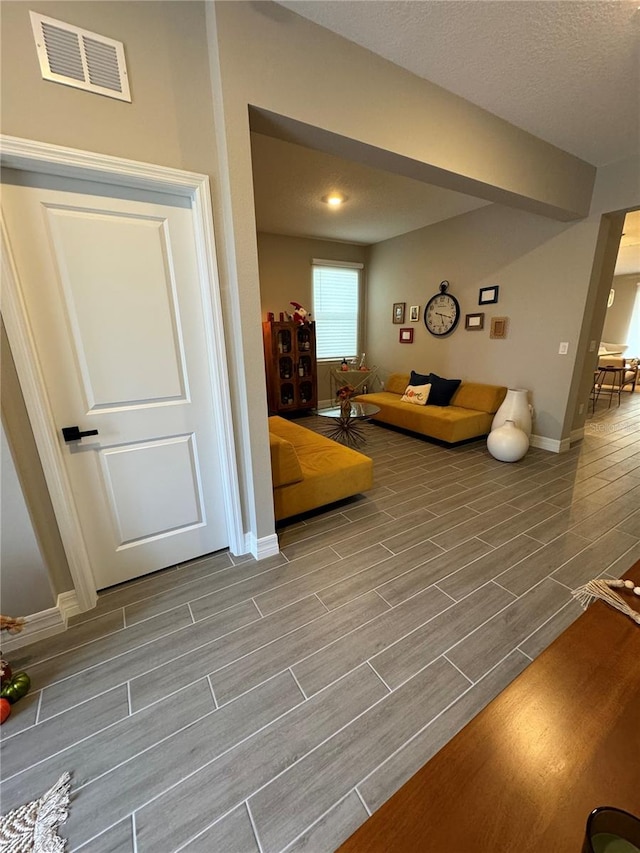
[0,773,71,853]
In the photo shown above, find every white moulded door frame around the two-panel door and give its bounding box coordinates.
[0,134,246,612]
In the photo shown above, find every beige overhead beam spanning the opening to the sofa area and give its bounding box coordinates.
[215,2,595,218]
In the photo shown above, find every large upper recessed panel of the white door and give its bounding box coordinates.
[44,205,186,409]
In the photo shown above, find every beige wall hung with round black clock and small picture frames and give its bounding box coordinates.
[366,205,598,440]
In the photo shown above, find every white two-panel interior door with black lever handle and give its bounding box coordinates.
[2,170,228,589]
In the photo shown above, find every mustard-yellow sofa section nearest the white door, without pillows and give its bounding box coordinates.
[269,415,373,521]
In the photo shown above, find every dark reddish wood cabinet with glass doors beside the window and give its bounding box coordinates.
[262,320,318,414]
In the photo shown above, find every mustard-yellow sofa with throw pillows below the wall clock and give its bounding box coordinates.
[354,373,507,444]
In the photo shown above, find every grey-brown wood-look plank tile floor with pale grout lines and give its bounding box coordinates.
[1,393,640,853]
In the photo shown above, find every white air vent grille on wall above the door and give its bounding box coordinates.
[29,12,131,102]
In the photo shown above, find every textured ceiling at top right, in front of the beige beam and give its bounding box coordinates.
[281,0,640,166]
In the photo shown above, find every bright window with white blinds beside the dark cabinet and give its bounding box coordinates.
[313,259,362,359]
